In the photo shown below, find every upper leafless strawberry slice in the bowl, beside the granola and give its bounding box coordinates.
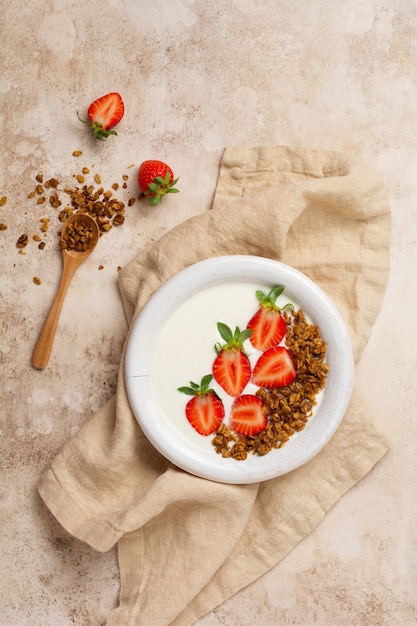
[252,346,297,387]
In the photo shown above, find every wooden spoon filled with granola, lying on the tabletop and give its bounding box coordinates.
[32,213,100,370]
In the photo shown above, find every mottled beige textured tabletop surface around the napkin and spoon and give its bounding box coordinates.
[0,0,417,626]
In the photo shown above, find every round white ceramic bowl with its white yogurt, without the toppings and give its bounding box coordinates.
[125,256,354,484]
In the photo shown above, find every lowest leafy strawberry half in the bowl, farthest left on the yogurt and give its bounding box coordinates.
[178,374,224,436]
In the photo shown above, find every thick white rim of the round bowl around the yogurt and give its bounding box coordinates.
[124,255,354,484]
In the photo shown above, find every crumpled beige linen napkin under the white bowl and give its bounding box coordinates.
[39,147,390,626]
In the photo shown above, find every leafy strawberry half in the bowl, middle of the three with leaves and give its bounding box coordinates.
[213,322,252,397]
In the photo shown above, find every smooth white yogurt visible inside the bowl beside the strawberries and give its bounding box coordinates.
[151,282,298,449]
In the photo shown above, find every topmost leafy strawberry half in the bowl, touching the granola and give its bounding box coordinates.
[247,285,291,352]
